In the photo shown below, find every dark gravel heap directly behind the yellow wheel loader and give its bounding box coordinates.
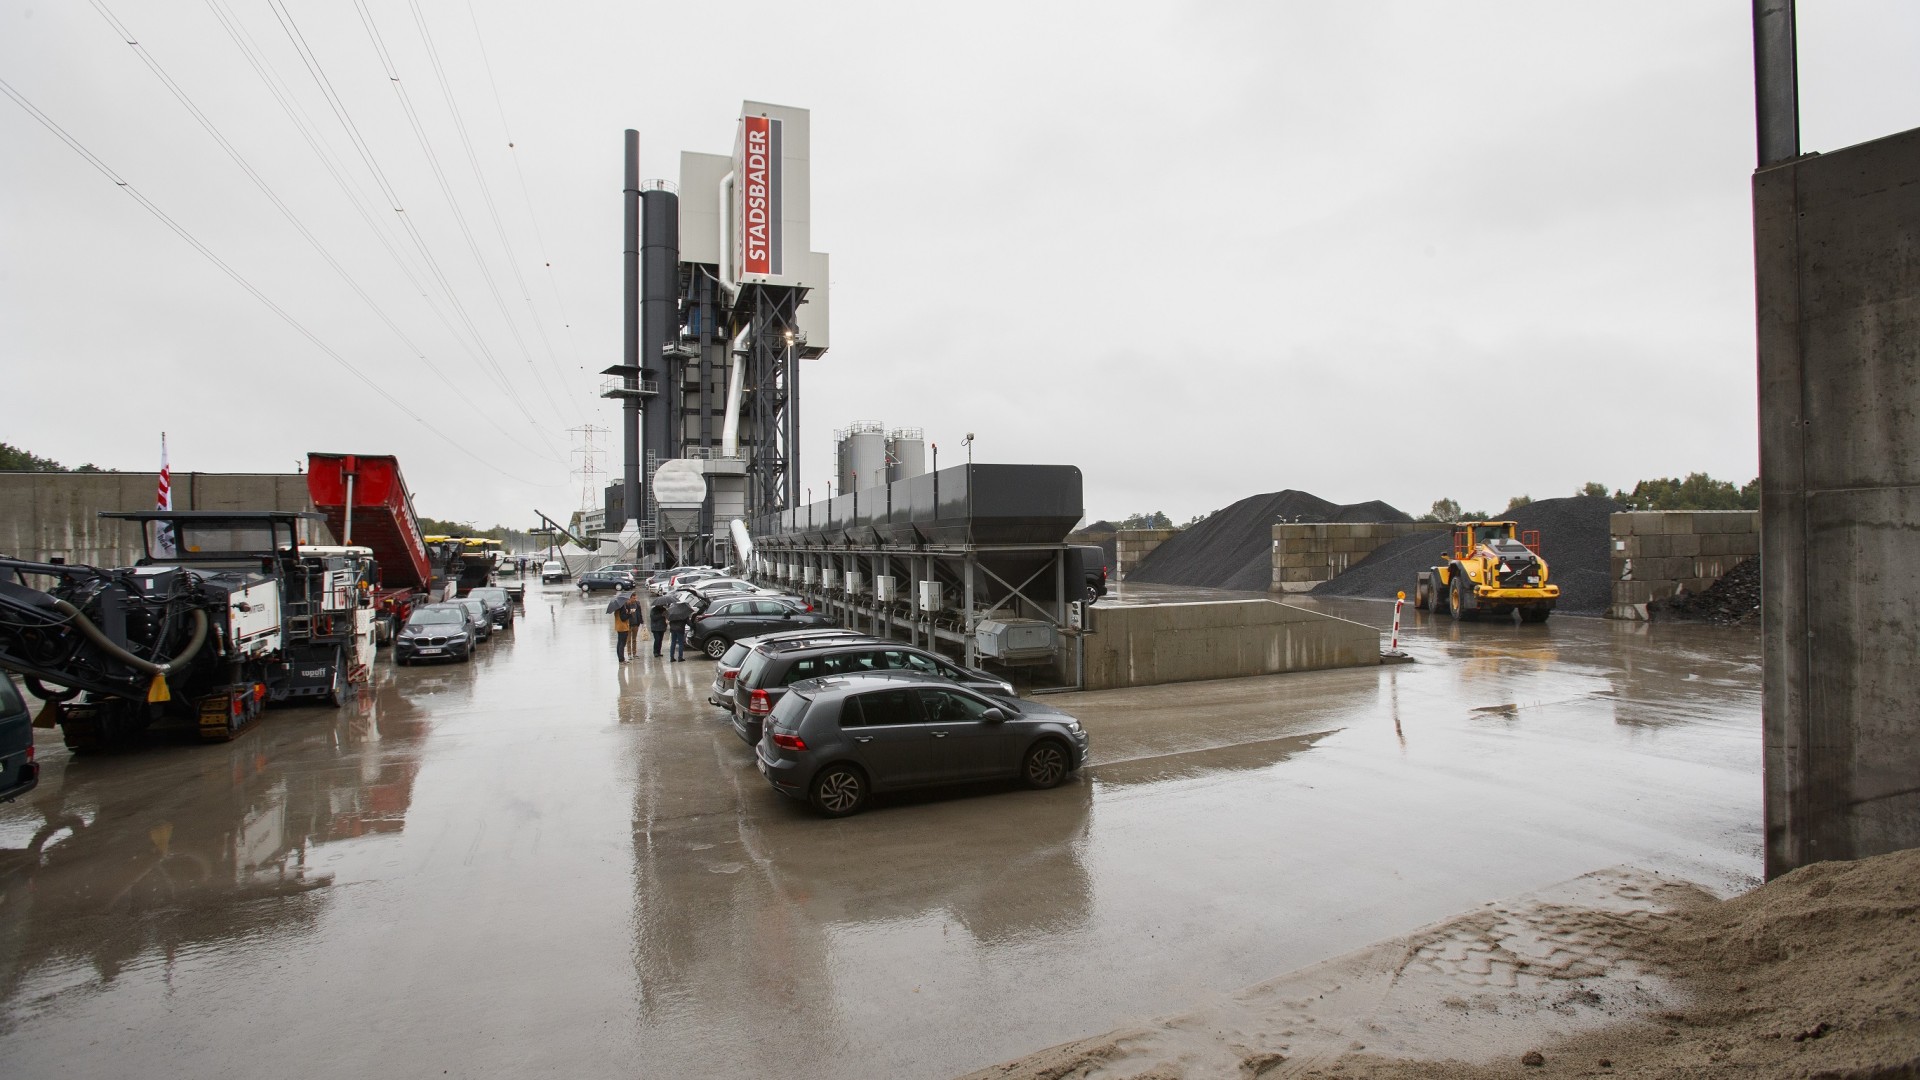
[1313,496,1626,615]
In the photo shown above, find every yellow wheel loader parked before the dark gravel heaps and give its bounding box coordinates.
[1413,521,1559,623]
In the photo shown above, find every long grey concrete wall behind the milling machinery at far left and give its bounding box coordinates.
[0,473,326,567]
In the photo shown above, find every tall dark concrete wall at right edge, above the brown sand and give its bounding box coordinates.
[1753,129,1920,876]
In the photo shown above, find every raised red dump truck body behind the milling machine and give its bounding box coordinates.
[307,454,434,636]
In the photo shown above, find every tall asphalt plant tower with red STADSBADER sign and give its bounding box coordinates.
[603,102,828,561]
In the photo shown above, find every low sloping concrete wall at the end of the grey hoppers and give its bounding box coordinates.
[1083,600,1380,690]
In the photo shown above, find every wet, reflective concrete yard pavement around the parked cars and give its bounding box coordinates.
[0,588,1761,1078]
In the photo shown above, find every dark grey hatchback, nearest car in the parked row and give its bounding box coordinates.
[755,671,1087,817]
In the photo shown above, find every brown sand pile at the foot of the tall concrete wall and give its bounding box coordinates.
[973,849,1920,1080]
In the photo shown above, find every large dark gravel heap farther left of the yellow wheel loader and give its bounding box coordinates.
[1127,488,1413,592]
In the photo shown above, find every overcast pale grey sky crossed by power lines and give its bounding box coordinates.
[0,0,1920,525]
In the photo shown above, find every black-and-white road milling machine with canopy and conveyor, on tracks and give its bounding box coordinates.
[0,509,374,753]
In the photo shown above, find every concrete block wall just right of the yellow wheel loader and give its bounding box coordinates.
[1607,509,1761,619]
